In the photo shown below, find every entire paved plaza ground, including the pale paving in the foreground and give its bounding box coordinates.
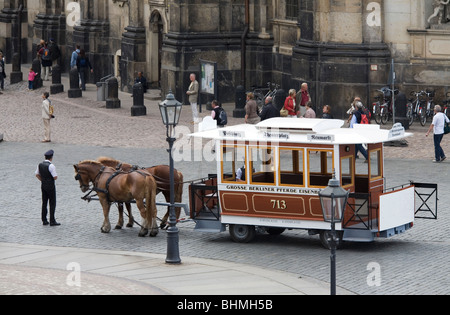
[0,67,450,295]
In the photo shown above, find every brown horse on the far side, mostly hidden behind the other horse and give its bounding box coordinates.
[97,156,183,228]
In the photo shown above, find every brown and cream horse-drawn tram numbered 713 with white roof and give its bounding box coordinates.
[189,118,437,246]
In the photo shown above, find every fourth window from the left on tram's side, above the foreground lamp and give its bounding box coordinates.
[307,149,334,187]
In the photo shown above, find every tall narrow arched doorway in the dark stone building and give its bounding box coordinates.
[147,10,164,88]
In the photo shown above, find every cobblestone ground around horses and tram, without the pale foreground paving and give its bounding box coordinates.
[0,65,450,294]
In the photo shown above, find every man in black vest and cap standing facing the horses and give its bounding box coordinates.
[35,150,60,226]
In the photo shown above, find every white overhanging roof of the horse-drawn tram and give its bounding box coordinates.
[189,118,412,144]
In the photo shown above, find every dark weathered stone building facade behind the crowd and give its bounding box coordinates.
[0,0,450,117]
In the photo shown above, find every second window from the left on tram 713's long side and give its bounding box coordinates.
[250,147,275,184]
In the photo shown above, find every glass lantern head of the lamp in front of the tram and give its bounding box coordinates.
[319,175,348,223]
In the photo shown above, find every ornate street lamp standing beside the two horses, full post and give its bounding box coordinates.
[159,90,183,264]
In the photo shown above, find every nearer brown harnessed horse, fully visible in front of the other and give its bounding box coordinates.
[74,160,158,236]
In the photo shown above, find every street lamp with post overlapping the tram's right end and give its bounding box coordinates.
[319,174,349,295]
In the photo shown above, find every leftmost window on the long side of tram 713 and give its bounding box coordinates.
[222,146,246,182]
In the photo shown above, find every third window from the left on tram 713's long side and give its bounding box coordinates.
[278,148,304,186]
